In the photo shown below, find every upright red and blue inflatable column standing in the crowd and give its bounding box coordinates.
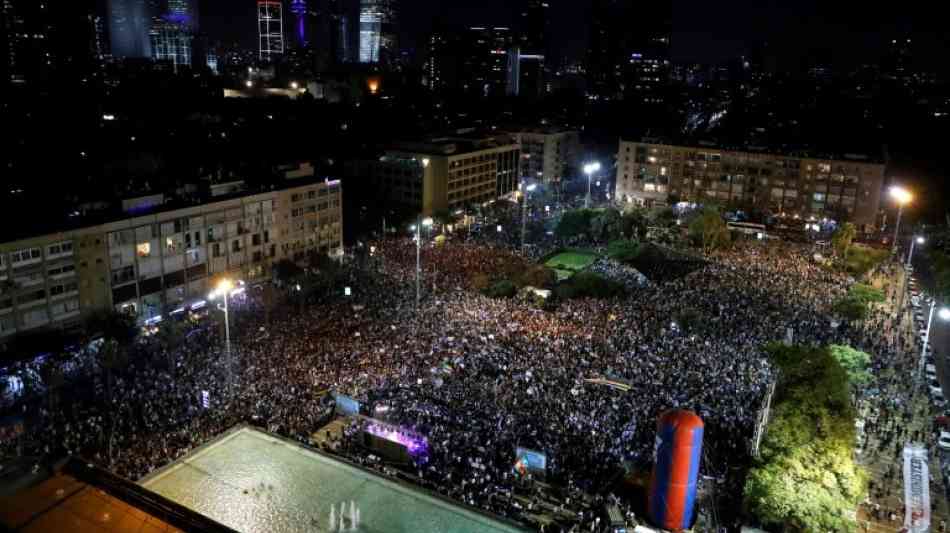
[648,409,704,531]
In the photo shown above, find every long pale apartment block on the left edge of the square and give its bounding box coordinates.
[0,178,343,338]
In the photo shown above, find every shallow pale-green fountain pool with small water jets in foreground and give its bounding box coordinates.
[139,426,522,533]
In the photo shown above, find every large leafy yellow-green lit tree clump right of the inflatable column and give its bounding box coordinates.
[744,345,867,531]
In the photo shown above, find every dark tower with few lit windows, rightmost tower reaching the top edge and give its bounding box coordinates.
[587,0,672,104]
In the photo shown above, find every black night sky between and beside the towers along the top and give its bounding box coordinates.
[201,0,950,71]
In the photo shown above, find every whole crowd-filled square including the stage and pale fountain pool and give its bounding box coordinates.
[0,205,944,532]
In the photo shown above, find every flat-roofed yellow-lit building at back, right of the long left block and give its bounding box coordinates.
[356,134,520,215]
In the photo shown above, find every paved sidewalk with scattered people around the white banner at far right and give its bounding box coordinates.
[857,269,950,533]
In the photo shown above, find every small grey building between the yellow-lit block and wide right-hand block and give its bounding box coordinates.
[510,127,581,184]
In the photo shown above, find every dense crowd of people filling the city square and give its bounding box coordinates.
[1,232,892,530]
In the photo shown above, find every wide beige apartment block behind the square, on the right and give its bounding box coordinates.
[617,140,885,230]
